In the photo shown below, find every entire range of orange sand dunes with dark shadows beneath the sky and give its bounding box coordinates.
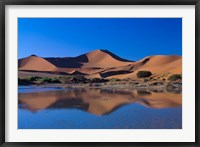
[18,50,182,79]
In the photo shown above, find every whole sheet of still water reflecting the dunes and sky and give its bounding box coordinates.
[18,86,182,129]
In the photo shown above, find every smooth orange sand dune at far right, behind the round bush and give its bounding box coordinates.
[106,55,182,79]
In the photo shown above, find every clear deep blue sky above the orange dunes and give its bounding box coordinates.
[18,18,182,60]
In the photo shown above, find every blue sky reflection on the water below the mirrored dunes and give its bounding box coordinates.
[18,86,182,129]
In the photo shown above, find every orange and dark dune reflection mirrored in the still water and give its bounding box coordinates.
[19,89,182,115]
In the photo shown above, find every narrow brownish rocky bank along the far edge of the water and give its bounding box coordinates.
[18,81,182,93]
